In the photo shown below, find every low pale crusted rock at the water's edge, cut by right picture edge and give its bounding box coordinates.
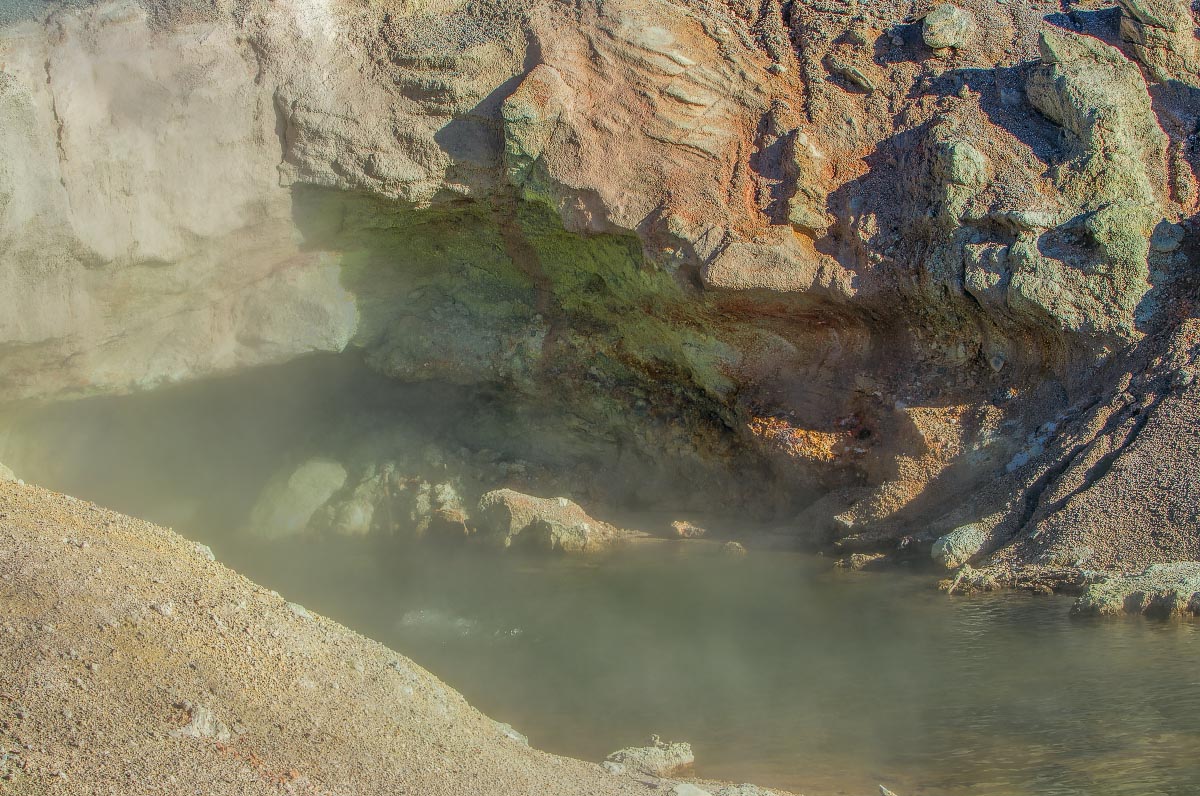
[1072,561,1200,616]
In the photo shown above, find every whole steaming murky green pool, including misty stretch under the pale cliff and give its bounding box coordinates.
[0,361,1200,796]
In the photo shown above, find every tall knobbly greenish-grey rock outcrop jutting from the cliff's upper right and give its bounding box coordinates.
[1006,28,1166,339]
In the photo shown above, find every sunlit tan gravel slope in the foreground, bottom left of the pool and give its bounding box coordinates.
[0,483,782,796]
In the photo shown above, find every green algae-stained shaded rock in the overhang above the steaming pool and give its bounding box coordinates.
[294,187,736,431]
